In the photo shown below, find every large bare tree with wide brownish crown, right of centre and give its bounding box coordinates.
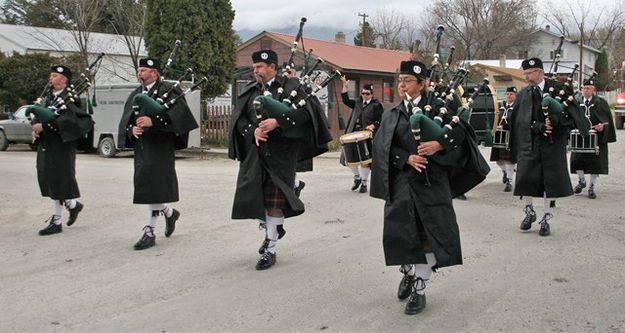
[429,0,536,59]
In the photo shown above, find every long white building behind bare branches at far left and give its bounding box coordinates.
[0,24,147,85]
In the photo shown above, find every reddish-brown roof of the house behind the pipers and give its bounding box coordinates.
[239,31,411,73]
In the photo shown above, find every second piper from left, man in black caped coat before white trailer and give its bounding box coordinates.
[118,58,198,250]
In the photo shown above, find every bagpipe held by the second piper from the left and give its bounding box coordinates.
[132,40,208,118]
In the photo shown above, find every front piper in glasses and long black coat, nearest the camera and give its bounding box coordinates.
[370,61,476,314]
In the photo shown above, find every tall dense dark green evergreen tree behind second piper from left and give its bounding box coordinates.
[145,0,236,97]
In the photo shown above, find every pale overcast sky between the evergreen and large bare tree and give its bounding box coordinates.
[231,0,432,42]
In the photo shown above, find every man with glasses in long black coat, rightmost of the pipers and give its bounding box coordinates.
[510,58,573,236]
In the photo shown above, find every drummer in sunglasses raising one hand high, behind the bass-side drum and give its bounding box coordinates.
[341,76,384,193]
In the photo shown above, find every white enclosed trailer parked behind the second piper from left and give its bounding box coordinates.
[93,85,201,157]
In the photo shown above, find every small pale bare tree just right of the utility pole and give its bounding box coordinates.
[370,8,406,50]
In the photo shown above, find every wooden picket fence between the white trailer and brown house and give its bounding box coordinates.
[201,105,232,146]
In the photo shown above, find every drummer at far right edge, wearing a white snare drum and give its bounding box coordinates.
[571,79,616,199]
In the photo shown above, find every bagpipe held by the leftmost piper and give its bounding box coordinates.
[25,53,104,124]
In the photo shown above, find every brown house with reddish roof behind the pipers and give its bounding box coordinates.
[233,31,412,138]
